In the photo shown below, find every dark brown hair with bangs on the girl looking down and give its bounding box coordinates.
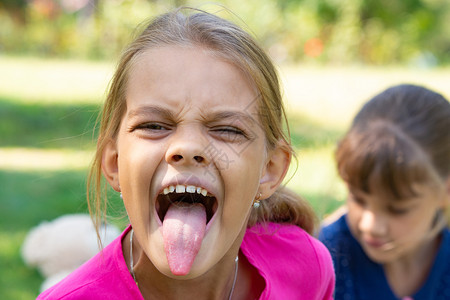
[336,85,450,199]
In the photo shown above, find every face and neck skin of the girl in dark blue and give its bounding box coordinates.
[347,179,449,297]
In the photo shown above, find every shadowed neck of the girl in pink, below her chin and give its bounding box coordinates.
[123,229,242,300]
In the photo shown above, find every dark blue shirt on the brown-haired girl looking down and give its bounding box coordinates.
[319,215,450,300]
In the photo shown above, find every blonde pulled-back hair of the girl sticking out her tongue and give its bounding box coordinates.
[88,8,315,237]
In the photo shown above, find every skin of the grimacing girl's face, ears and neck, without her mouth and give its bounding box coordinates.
[102,46,290,299]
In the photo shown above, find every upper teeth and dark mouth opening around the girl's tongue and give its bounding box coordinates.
[156,185,218,224]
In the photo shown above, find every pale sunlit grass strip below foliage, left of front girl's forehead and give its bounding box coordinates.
[0,55,113,104]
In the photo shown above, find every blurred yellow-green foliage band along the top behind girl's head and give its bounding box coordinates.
[0,0,450,66]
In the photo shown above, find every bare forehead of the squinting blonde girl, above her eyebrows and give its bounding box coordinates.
[126,45,259,111]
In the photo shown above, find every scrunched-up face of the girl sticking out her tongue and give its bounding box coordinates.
[102,46,284,278]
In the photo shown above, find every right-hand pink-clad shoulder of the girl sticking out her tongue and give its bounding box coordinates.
[241,223,334,299]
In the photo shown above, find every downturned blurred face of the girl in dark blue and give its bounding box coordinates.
[347,185,445,264]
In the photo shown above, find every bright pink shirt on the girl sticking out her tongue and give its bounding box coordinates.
[37,223,335,300]
